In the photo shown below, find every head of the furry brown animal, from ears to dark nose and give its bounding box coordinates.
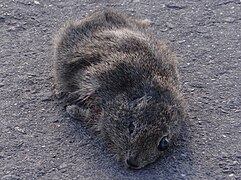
[100,84,183,169]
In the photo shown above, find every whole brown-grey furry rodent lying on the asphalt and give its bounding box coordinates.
[54,9,185,169]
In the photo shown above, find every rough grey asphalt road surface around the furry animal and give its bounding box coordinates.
[0,0,241,180]
